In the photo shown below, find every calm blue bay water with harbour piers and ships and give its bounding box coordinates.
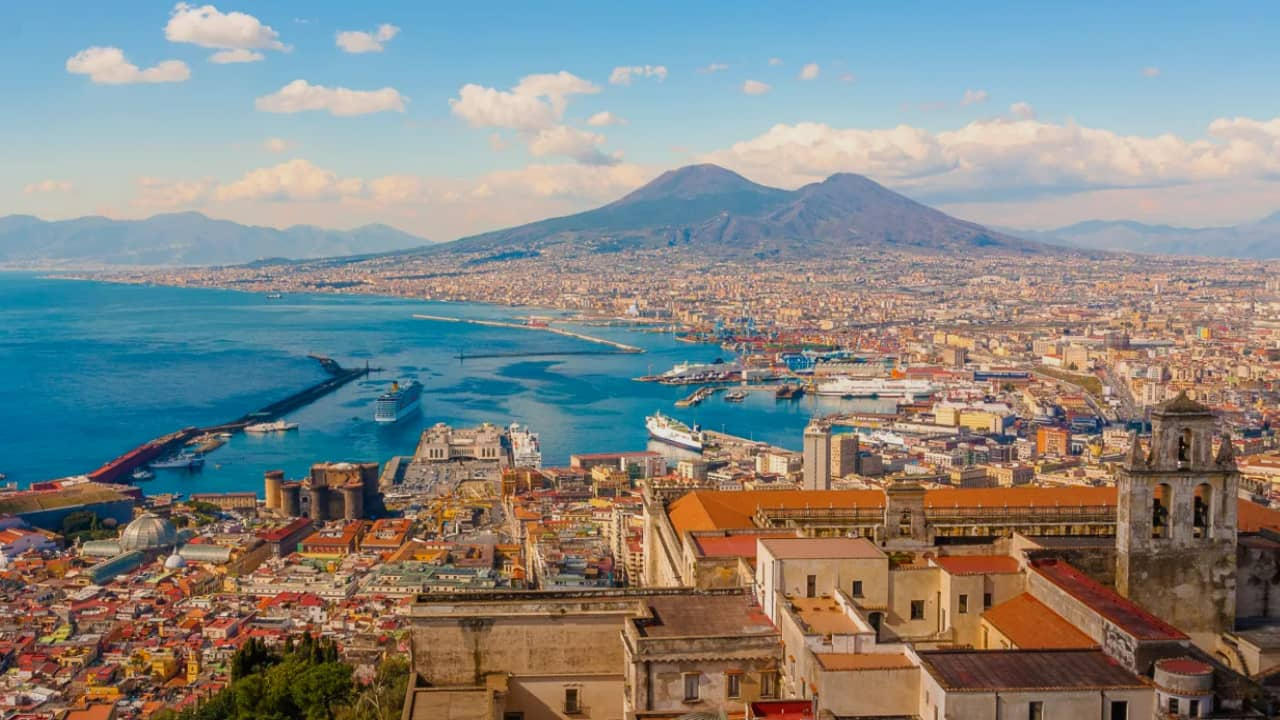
[0,273,890,493]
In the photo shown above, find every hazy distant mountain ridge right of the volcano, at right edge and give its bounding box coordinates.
[1007,213,1280,259]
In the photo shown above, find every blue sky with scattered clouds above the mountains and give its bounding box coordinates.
[0,0,1280,241]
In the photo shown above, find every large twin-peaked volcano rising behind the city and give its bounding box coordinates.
[430,165,1048,261]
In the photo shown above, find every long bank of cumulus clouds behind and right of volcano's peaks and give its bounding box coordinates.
[701,112,1280,199]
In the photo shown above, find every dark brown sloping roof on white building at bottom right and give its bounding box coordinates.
[919,650,1147,692]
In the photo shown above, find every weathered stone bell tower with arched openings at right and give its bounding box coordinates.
[1116,392,1240,639]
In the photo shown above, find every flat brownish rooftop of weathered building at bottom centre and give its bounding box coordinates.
[632,593,778,638]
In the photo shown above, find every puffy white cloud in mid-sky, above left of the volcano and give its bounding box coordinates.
[449,70,600,129]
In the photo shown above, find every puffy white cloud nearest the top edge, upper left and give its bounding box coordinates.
[164,3,289,63]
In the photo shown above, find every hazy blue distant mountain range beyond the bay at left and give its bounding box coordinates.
[0,213,426,268]
